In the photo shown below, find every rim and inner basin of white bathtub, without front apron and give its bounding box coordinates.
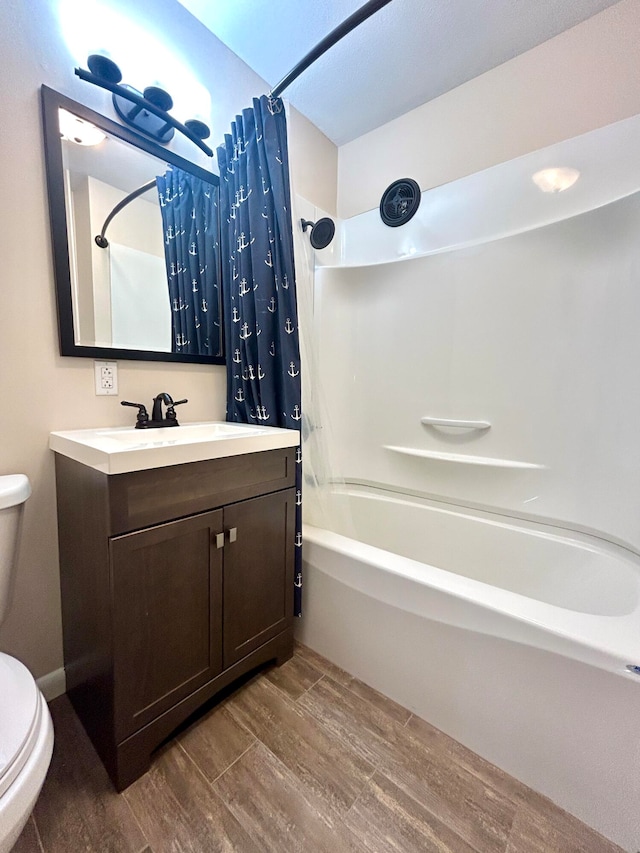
[304,487,640,689]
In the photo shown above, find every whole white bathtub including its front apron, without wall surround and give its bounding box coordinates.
[298,486,640,851]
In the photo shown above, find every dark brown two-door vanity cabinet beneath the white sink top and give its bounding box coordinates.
[56,449,295,790]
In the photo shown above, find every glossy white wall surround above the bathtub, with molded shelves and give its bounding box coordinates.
[316,148,640,554]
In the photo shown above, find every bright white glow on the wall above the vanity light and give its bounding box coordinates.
[58,0,211,126]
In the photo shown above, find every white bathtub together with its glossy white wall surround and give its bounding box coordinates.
[300,117,640,851]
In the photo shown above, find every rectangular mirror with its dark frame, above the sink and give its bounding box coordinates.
[42,86,224,364]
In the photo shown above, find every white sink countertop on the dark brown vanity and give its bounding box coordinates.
[49,421,300,474]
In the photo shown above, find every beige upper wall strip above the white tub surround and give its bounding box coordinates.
[338,0,640,218]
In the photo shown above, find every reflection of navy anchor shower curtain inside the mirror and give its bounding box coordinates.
[156,168,220,355]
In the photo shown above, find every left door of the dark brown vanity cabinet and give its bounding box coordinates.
[111,510,223,740]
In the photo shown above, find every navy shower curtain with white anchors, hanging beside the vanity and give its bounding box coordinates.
[217,95,302,616]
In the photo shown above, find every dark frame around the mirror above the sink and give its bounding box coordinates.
[41,86,225,364]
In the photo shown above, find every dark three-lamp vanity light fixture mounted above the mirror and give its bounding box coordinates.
[75,53,213,157]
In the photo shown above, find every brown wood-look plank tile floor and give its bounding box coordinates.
[14,645,620,853]
